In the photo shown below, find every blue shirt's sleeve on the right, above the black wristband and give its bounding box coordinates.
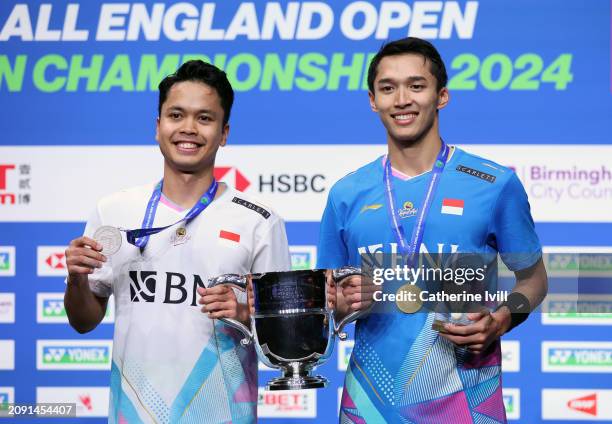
[491,173,542,271]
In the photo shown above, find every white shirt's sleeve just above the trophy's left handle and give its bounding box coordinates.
[251,215,291,273]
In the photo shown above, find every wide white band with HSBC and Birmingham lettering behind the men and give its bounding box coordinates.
[0,144,612,222]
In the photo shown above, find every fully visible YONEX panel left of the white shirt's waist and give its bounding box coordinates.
[36,340,113,370]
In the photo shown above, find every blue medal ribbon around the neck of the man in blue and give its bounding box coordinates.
[384,141,450,266]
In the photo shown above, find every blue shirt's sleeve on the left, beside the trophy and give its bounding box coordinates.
[317,192,348,268]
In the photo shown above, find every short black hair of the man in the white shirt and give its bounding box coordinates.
[157,60,234,125]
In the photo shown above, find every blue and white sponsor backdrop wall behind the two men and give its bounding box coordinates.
[0,0,612,423]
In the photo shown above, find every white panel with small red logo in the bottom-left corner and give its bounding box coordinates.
[36,387,110,417]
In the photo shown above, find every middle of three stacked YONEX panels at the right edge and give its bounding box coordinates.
[542,293,612,325]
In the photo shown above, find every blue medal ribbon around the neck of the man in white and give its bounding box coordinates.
[126,178,219,251]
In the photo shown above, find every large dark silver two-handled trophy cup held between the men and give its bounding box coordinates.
[208,267,366,390]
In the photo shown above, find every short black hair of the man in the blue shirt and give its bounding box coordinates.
[368,37,448,93]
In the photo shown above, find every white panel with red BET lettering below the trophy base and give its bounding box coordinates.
[257,387,317,418]
